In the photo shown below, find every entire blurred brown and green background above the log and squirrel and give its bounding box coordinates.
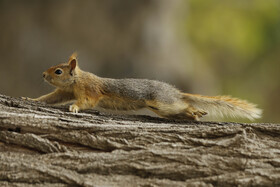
[0,0,280,122]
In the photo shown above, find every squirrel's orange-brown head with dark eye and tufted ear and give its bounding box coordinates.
[43,53,79,88]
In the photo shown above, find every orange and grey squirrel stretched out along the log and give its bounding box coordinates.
[26,53,262,121]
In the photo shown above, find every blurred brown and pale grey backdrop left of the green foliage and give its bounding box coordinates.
[0,0,192,97]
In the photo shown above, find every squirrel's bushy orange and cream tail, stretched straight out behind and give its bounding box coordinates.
[184,93,262,120]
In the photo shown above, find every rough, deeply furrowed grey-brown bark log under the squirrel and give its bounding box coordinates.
[0,95,280,186]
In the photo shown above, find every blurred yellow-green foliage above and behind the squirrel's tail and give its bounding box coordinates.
[184,0,280,122]
